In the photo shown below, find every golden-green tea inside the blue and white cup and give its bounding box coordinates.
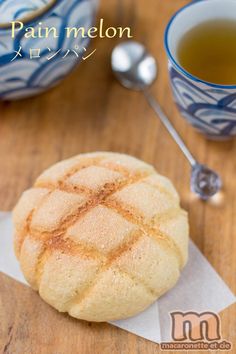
[177,19,236,85]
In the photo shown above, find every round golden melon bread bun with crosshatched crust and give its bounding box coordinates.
[14,152,188,322]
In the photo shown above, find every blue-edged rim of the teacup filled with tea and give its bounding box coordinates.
[164,0,236,89]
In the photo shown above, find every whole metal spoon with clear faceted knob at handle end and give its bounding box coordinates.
[111,41,222,200]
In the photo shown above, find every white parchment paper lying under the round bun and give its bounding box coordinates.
[0,212,235,343]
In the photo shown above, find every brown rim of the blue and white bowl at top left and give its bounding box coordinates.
[0,0,62,32]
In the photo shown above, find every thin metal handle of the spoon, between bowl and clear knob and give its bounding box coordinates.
[143,91,197,167]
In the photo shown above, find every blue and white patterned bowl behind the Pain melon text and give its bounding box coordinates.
[0,0,98,100]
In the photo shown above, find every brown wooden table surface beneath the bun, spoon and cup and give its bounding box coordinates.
[0,0,236,354]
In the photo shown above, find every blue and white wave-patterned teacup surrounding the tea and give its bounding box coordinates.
[165,0,236,140]
